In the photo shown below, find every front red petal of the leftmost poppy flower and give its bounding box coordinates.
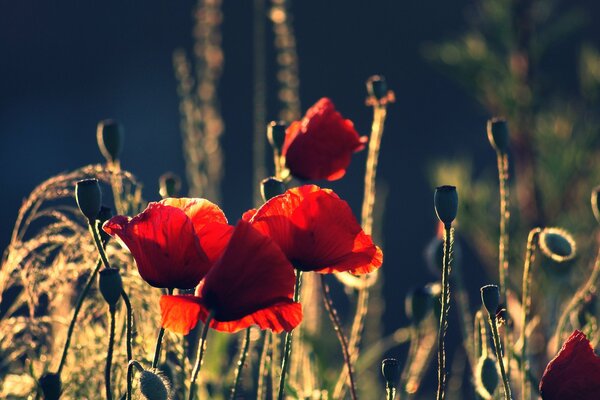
[104,203,211,289]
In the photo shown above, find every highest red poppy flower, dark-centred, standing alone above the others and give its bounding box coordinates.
[282,97,368,181]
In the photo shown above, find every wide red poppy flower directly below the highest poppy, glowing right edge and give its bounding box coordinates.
[245,185,383,274]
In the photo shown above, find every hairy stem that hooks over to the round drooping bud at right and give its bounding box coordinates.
[520,228,541,399]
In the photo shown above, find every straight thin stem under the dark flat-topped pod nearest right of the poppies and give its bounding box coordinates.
[437,225,454,400]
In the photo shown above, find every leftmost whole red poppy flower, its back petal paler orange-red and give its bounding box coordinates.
[103,198,233,289]
